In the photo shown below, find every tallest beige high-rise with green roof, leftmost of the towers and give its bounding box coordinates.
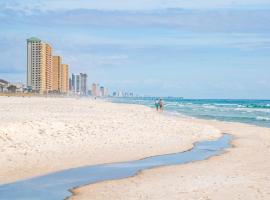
[27,37,52,94]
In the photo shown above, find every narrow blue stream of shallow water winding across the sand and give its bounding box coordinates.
[0,134,232,200]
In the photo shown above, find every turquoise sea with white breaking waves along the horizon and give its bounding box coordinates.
[110,98,270,127]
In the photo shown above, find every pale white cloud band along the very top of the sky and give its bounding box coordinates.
[0,0,270,10]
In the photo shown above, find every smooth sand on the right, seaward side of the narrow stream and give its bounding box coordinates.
[72,120,270,200]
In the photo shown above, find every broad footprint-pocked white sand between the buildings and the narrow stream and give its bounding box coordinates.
[0,97,220,184]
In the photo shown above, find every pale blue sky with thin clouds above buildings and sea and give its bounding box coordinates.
[0,0,270,99]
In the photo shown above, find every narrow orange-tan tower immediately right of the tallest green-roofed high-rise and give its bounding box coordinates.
[52,56,62,92]
